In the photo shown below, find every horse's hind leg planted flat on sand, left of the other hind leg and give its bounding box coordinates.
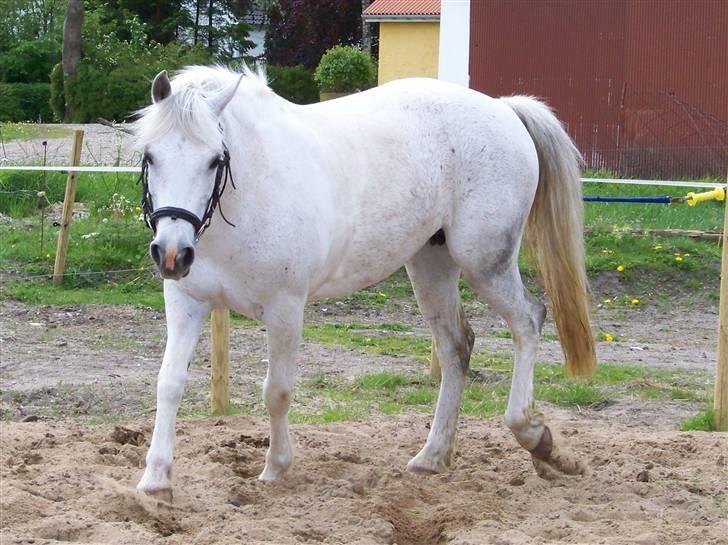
[407,241,475,473]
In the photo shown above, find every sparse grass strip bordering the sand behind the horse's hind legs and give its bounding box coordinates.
[278,354,711,429]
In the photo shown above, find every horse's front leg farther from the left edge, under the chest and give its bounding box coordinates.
[258,298,305,481]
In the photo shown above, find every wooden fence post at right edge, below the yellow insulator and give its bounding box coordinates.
[713,170,728,431]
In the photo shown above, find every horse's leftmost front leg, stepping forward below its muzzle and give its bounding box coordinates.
[137,280,210,501]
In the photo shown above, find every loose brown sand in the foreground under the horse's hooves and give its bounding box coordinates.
[0,410,728,545]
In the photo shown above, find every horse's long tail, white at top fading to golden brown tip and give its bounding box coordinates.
[502,96,597,376]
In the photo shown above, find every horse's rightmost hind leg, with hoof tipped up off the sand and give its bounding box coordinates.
[465,262,585,478]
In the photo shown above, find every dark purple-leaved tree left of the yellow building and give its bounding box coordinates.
[265,0,362,69]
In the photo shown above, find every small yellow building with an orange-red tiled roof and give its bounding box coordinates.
[363,0,440,85]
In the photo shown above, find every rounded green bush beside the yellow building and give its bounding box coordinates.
[314,45,377,93]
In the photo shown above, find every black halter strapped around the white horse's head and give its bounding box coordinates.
[139,148,237,242]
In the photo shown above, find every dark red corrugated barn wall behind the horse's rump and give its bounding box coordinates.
[440,0,728,177]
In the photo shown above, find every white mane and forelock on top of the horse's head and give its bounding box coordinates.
[132,65,272,149]
